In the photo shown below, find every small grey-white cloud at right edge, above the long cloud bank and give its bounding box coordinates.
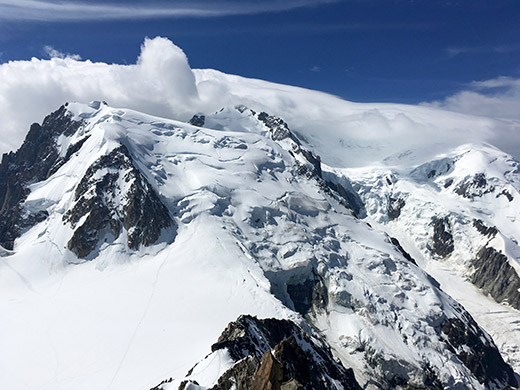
[424,76,520,119]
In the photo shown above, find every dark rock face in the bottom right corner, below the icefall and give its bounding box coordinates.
[441,314,517,389]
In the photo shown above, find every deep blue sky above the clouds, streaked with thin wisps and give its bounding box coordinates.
[0,0,520,103]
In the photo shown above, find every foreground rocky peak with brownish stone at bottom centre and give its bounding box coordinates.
[207,316,361,390]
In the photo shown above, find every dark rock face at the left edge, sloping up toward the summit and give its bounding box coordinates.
[0,106,82,249]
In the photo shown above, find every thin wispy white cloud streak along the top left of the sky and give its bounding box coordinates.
[0,0,341,22]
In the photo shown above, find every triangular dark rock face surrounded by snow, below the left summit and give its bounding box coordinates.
[63,146,174,258]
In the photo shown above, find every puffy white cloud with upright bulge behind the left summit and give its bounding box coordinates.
[0,37,198,153]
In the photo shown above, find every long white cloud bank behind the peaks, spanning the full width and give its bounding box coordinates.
[0,37,520,166]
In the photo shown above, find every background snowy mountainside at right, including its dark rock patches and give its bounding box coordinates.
[342,144,520,370]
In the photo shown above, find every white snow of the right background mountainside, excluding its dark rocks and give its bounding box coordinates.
[341,144,520,373]
